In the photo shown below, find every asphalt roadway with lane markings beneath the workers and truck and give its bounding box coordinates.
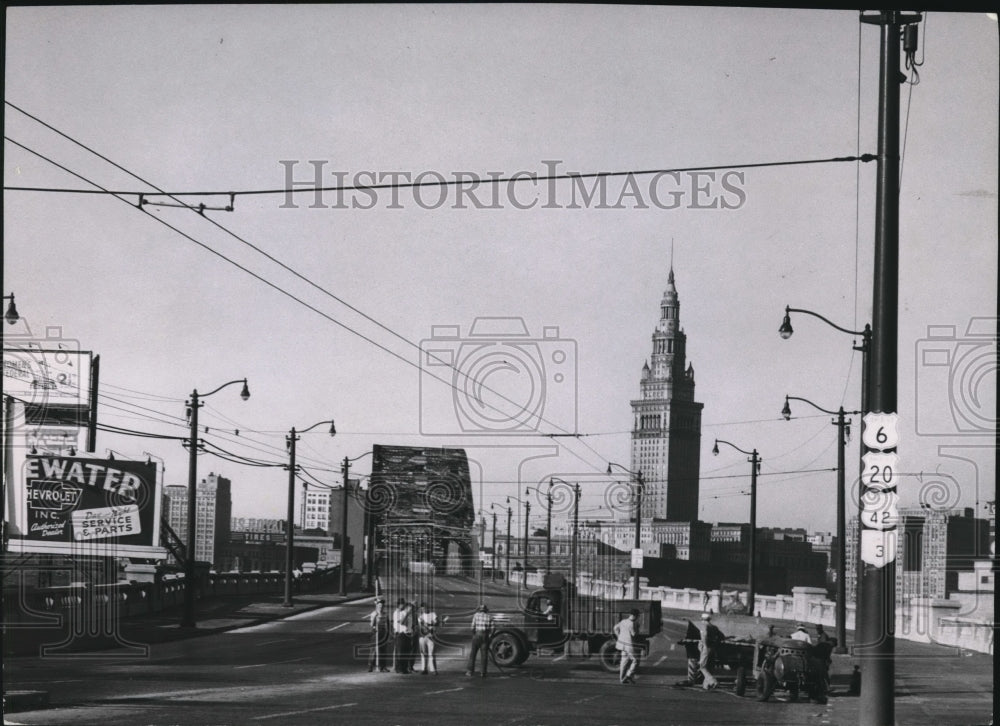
[4,577,993,726]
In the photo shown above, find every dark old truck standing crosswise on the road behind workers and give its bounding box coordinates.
[490,573,662,672]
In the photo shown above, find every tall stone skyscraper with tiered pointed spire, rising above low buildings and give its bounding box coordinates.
[631,266,703,522]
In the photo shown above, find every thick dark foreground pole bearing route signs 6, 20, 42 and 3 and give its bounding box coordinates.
[856,10,921,726]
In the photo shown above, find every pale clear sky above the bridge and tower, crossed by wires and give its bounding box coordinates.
[3,5,1000,531]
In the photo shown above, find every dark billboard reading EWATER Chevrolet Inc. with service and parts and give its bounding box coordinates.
[9,454,166,559]
